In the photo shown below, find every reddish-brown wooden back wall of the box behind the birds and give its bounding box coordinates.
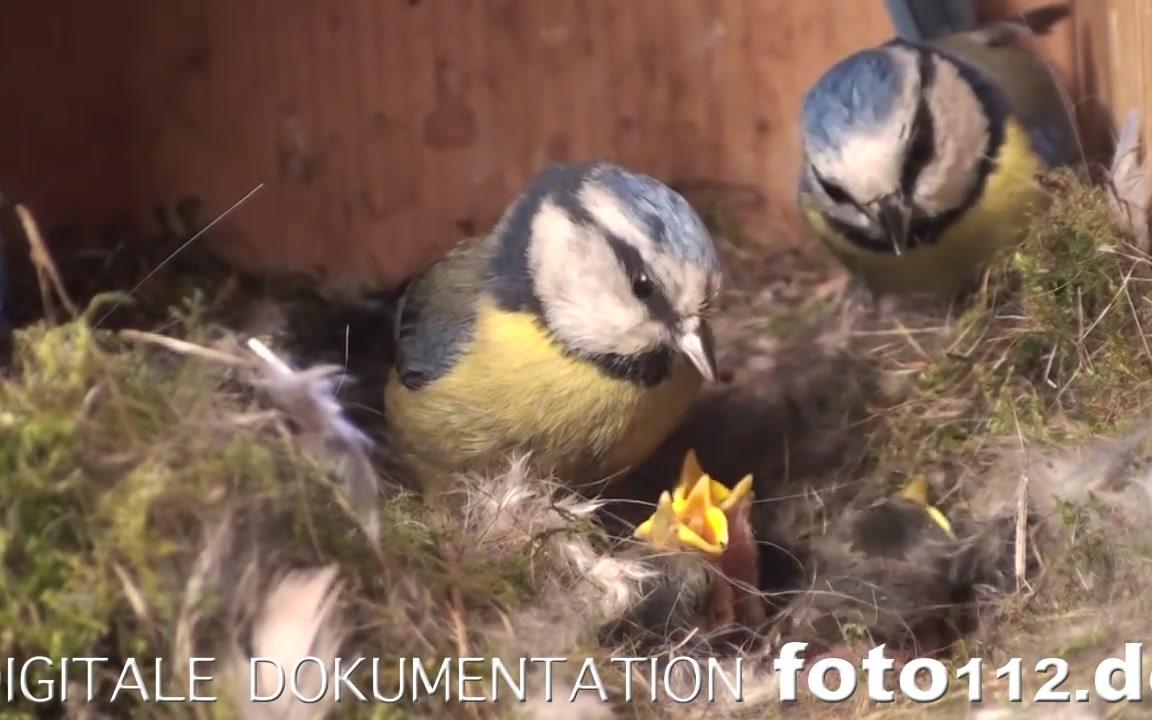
[0,0,1087,283]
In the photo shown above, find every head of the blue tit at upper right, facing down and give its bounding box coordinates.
[802,43,993,255]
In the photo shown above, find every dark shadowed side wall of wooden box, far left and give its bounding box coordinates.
[0,1,136,219]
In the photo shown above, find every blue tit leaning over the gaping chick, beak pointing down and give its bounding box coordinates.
[385,162,720,492]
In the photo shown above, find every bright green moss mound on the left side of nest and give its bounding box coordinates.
[0,297,566,718]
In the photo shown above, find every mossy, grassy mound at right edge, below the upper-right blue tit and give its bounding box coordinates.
[877,173,1152,467]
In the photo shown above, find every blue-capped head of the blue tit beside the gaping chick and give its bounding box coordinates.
[497,162,720,380]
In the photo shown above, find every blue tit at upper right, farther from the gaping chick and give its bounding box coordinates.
[799,0,1083,296]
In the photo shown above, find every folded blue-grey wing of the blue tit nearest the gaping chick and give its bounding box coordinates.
[395,238,490,389]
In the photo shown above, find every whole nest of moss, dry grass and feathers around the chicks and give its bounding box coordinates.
[0,164,1152,717]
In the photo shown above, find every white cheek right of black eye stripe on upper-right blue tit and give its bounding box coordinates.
[915,58,990,214]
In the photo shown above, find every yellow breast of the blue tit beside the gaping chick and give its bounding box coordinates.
[389,306,702,472]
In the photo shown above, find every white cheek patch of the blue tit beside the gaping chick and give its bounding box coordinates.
[529,202,658,354]
